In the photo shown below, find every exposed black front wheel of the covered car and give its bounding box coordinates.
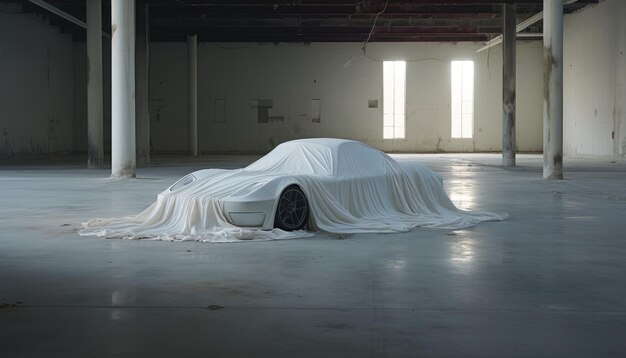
[274,185,309,231]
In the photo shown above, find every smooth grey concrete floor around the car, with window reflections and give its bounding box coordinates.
[0,154,626,357]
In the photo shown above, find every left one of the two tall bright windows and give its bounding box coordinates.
[383,61,406,139]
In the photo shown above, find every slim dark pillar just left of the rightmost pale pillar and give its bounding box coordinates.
[502,4,517,167]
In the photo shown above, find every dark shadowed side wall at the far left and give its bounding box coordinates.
[0,3,74,157]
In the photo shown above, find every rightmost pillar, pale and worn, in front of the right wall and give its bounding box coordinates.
[543,0,563,179]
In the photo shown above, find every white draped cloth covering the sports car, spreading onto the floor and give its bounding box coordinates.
[80,139,506,242]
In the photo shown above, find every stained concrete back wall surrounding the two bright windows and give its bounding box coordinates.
[150,42,543,152]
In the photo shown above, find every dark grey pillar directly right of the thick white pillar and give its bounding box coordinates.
[135,4,150,164]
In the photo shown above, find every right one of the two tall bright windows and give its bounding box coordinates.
[452,61,474,138]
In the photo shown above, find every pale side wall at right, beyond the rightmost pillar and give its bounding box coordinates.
[563,0,626,156]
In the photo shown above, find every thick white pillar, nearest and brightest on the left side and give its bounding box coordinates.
[111,0,136,178]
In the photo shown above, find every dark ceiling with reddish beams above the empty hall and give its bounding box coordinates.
[13,0,599,42]
